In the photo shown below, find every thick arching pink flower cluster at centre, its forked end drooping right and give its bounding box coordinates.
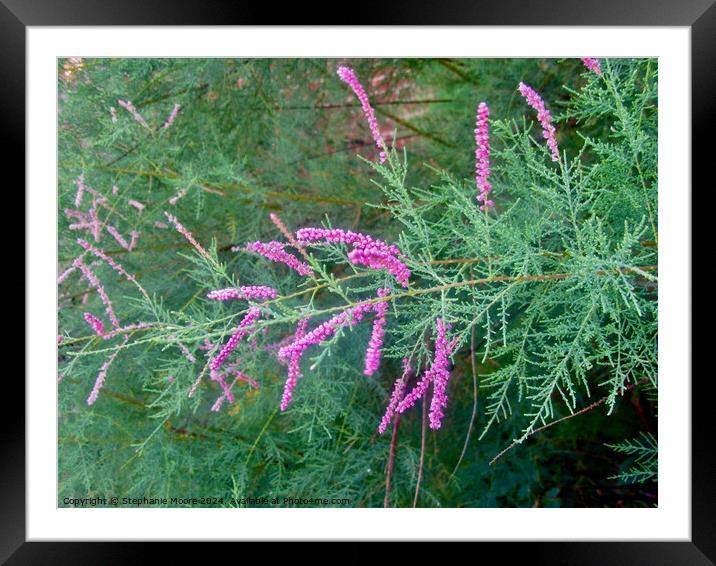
[296,227,410,287]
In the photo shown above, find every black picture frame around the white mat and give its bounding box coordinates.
[9,0,704,566]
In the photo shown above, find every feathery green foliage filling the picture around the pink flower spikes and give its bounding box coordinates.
[58,59,658,507]
